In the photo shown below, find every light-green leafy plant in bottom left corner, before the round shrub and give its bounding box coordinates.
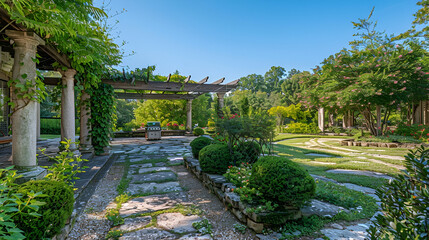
[0,166,45,240]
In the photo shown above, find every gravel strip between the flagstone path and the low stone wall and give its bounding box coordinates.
[172,165,258,240]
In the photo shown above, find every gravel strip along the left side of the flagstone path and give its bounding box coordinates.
[67,166,124,240]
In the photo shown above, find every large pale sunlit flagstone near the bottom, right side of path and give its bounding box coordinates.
[157,213,201,234]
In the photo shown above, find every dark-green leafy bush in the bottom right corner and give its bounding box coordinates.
[368,147,429,240]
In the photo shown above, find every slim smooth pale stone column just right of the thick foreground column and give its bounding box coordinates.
[61,69,76,151]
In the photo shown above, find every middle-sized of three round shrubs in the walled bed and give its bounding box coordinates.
[199,144,232,174]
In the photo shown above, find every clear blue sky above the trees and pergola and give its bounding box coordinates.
[96,0,418,83]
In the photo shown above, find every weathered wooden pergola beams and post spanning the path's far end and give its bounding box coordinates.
[103,74,239,130]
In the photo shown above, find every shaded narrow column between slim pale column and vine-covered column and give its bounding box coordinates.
[79,90,92,152]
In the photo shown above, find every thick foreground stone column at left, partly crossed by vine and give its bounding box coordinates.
[6,30,45,174]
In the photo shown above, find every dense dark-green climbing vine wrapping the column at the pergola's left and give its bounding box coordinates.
[88,83,116,155]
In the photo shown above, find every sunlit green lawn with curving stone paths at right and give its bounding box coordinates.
[274,134,408,188]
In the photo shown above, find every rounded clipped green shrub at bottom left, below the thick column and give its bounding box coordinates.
[13,180,74,239]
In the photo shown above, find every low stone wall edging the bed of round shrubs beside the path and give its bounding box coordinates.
[184,157,302,233]
